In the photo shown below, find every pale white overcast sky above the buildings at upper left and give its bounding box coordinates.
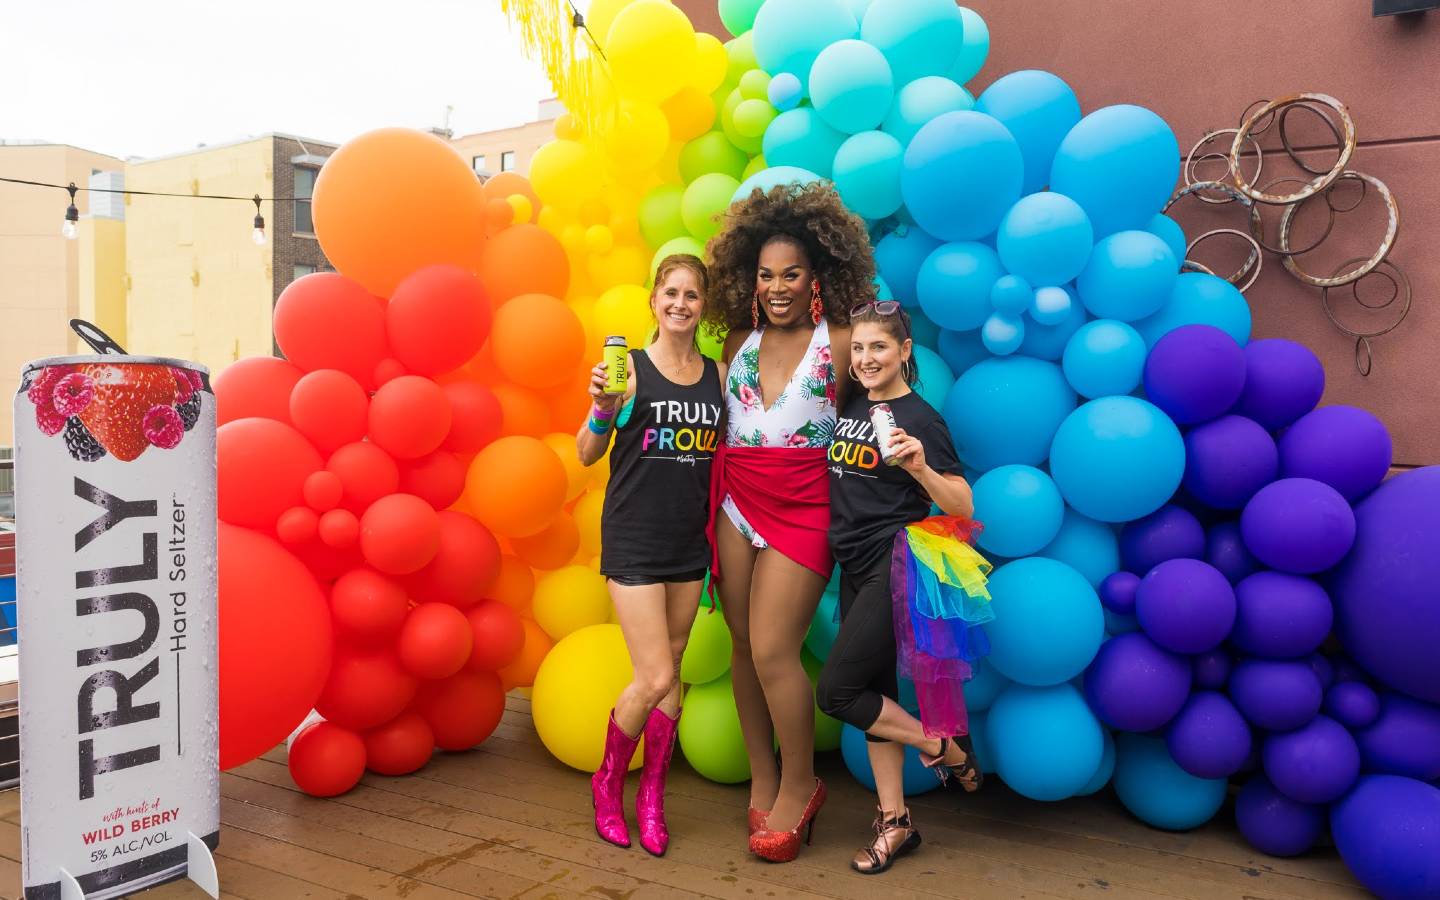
[0,0,550,157]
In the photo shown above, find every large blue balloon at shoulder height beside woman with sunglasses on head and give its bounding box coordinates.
[943,356,1076,471]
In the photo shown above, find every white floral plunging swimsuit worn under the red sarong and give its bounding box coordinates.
[720,320,837,550]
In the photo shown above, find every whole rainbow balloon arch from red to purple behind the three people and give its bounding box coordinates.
[215,0,1440,896]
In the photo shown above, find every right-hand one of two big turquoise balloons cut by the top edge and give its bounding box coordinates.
[860,0,965,85]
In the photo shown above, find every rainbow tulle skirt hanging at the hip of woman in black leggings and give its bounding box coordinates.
[890,516,995,737]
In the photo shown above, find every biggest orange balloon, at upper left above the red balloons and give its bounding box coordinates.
[312,128,485,297]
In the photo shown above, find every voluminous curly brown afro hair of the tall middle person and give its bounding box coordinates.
[706,181,876,333]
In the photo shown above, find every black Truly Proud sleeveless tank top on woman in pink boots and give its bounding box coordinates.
[600,350,723,576]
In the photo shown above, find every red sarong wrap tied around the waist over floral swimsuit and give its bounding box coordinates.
[706,446,835,612]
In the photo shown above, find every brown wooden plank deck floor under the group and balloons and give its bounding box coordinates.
[0,698,1367,900]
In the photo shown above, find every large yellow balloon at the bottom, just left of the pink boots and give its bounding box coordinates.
[530,625,645,772]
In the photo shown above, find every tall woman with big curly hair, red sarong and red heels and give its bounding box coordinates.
[707,184,876,861]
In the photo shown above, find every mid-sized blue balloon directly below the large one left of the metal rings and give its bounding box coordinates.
[1076,230,1179,323]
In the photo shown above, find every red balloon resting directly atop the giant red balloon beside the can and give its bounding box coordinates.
[216,419,321,530]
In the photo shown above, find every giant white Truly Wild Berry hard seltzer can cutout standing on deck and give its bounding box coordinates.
[14,354,220,897]
